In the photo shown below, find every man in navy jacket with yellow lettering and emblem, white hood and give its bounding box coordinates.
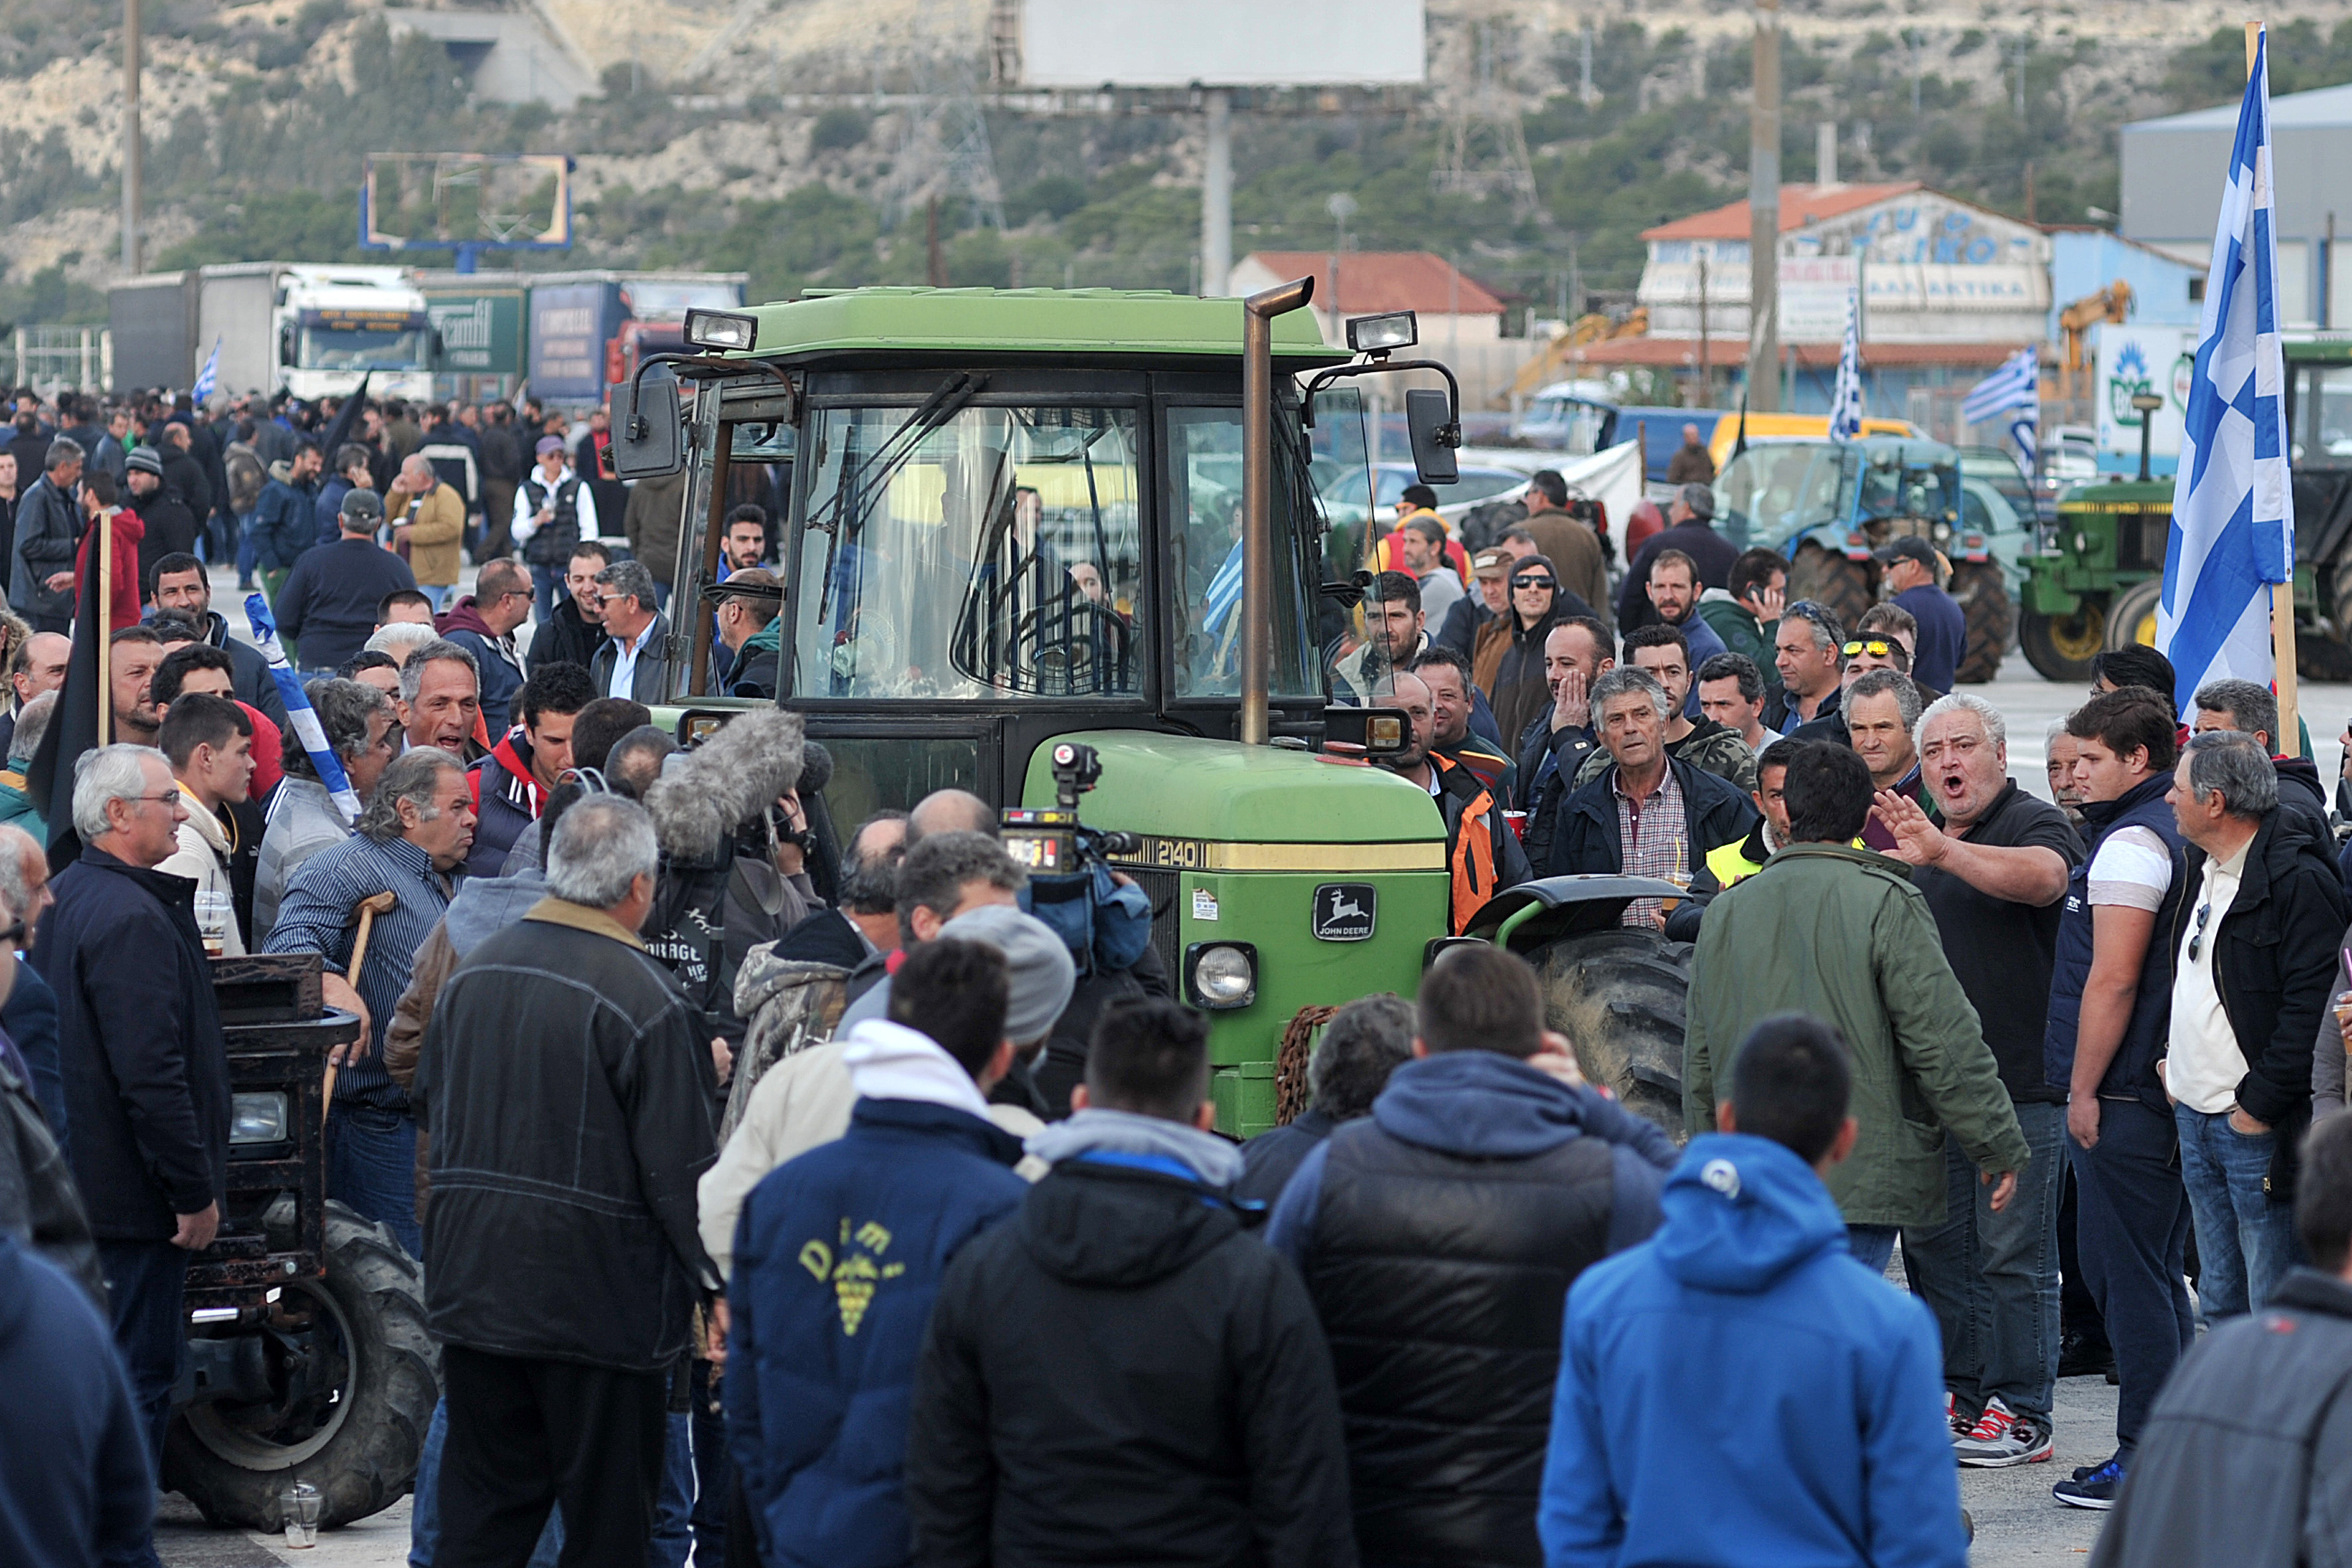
[724,938,1028,1568]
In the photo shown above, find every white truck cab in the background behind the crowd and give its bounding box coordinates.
[273,266,440,402]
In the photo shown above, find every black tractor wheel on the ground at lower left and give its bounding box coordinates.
[162,1204,440,1530]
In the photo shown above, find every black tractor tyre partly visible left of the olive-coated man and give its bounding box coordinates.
[1529,926,1691,1138]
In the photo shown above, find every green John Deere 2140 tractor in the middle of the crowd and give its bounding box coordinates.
[635,289,1449,1135]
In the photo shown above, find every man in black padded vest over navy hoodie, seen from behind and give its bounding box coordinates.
[1265,947,1675,1568]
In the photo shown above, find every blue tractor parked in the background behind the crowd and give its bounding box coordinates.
[1715,435,2035,684]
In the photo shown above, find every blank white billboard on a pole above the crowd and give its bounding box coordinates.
[1021,0,1425,87]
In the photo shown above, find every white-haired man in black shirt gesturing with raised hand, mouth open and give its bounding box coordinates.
[1855,677,2084,1469]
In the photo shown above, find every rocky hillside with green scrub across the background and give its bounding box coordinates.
[0,0,2352,320]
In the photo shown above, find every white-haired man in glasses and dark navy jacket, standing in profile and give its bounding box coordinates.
[33,745,228,1532]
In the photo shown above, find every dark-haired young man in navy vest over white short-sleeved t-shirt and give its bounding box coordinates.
[2044,686,2192,1509]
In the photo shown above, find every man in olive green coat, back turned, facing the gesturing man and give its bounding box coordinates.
[1682,743,2027,1269]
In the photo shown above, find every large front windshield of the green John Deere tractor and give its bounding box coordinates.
[795,407,1148,700]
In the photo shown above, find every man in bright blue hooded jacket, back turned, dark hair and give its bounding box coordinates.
[1536,1013,1968,1568]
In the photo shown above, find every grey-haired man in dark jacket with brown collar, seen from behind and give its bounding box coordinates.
[414,795,720,1563]
